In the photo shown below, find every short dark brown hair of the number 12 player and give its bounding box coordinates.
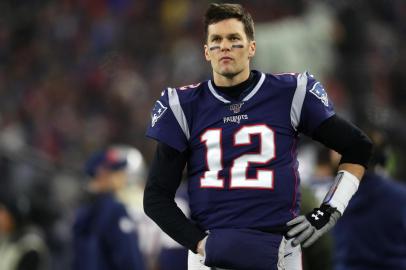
[204,3,254,41]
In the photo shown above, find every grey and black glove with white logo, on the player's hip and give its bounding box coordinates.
[287,204,341,247]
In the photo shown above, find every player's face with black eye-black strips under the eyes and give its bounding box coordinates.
[204,19,255,78]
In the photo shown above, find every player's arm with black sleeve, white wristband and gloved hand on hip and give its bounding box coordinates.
[287,116,372,247]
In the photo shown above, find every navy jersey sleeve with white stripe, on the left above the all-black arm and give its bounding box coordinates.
[146,88,188,152]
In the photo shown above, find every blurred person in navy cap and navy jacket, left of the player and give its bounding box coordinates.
[73,148,145,270]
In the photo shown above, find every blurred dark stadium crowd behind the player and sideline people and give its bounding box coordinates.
[0,0,406,270]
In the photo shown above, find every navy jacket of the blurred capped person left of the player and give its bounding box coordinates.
[73,194,145,270]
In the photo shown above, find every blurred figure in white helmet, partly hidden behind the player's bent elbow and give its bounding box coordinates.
[110,145,189,270]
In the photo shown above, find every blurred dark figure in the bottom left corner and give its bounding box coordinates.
[0,190,49,270]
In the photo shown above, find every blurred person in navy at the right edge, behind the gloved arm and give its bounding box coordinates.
[333,131,406,270]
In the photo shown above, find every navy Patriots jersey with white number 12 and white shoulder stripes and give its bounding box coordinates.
[147,71,334,230]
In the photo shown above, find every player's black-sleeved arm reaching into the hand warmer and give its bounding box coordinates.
[144,143,206,253]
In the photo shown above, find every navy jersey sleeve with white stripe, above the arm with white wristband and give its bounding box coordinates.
[291,72,335,136]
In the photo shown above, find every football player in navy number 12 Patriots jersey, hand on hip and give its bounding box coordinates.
[144,4,371,270]
